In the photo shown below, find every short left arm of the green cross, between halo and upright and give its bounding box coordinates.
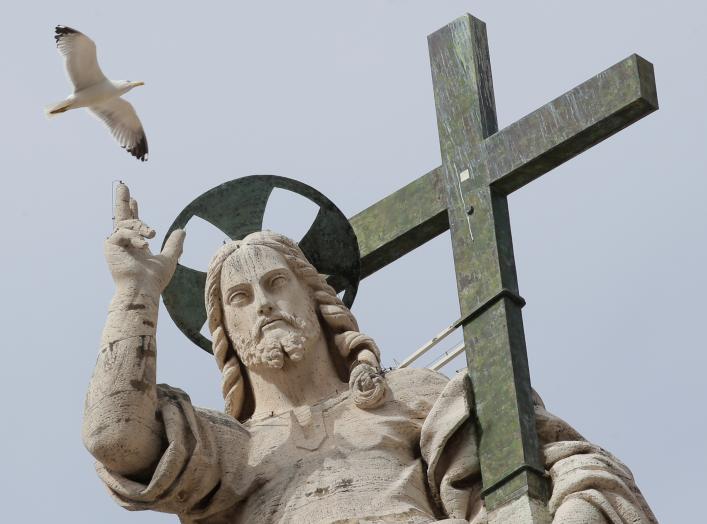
[350,166,449,278]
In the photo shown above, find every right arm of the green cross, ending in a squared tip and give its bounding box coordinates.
[482,54,658,195]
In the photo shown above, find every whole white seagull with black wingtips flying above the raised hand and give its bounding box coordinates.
[46,25,147,162]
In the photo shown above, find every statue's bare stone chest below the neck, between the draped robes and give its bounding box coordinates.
[241,394,434,523]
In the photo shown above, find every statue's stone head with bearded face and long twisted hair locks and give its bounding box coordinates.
[205,231,385,420]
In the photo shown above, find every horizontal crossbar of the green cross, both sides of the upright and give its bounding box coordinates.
[351,55,658,277]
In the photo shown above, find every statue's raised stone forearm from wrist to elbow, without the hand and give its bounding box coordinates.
[83,292,164,476]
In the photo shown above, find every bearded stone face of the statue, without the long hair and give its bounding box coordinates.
[221,245,321,368]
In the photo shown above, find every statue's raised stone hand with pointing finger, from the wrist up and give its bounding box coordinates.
[104,183,186,300]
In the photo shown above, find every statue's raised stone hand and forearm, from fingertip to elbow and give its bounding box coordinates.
[88,183,184,472]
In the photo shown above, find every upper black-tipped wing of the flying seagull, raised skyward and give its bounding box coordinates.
[54,25,106,91]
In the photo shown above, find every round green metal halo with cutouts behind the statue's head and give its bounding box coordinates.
[162,175,360,353]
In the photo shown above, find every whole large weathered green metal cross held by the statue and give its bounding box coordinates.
[351,15,658,522]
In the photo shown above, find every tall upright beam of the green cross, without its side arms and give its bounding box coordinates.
[428,15,548,522]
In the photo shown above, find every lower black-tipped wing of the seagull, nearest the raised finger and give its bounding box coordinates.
[88,97,147,162]
